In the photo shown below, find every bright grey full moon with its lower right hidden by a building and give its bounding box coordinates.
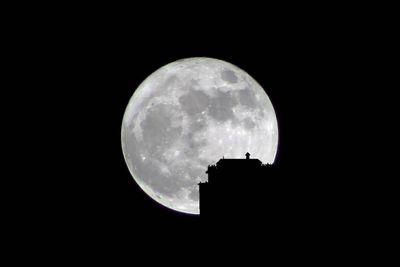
[121,58,278,214]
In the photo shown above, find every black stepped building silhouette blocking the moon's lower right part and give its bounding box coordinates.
[199,152,277,222]
